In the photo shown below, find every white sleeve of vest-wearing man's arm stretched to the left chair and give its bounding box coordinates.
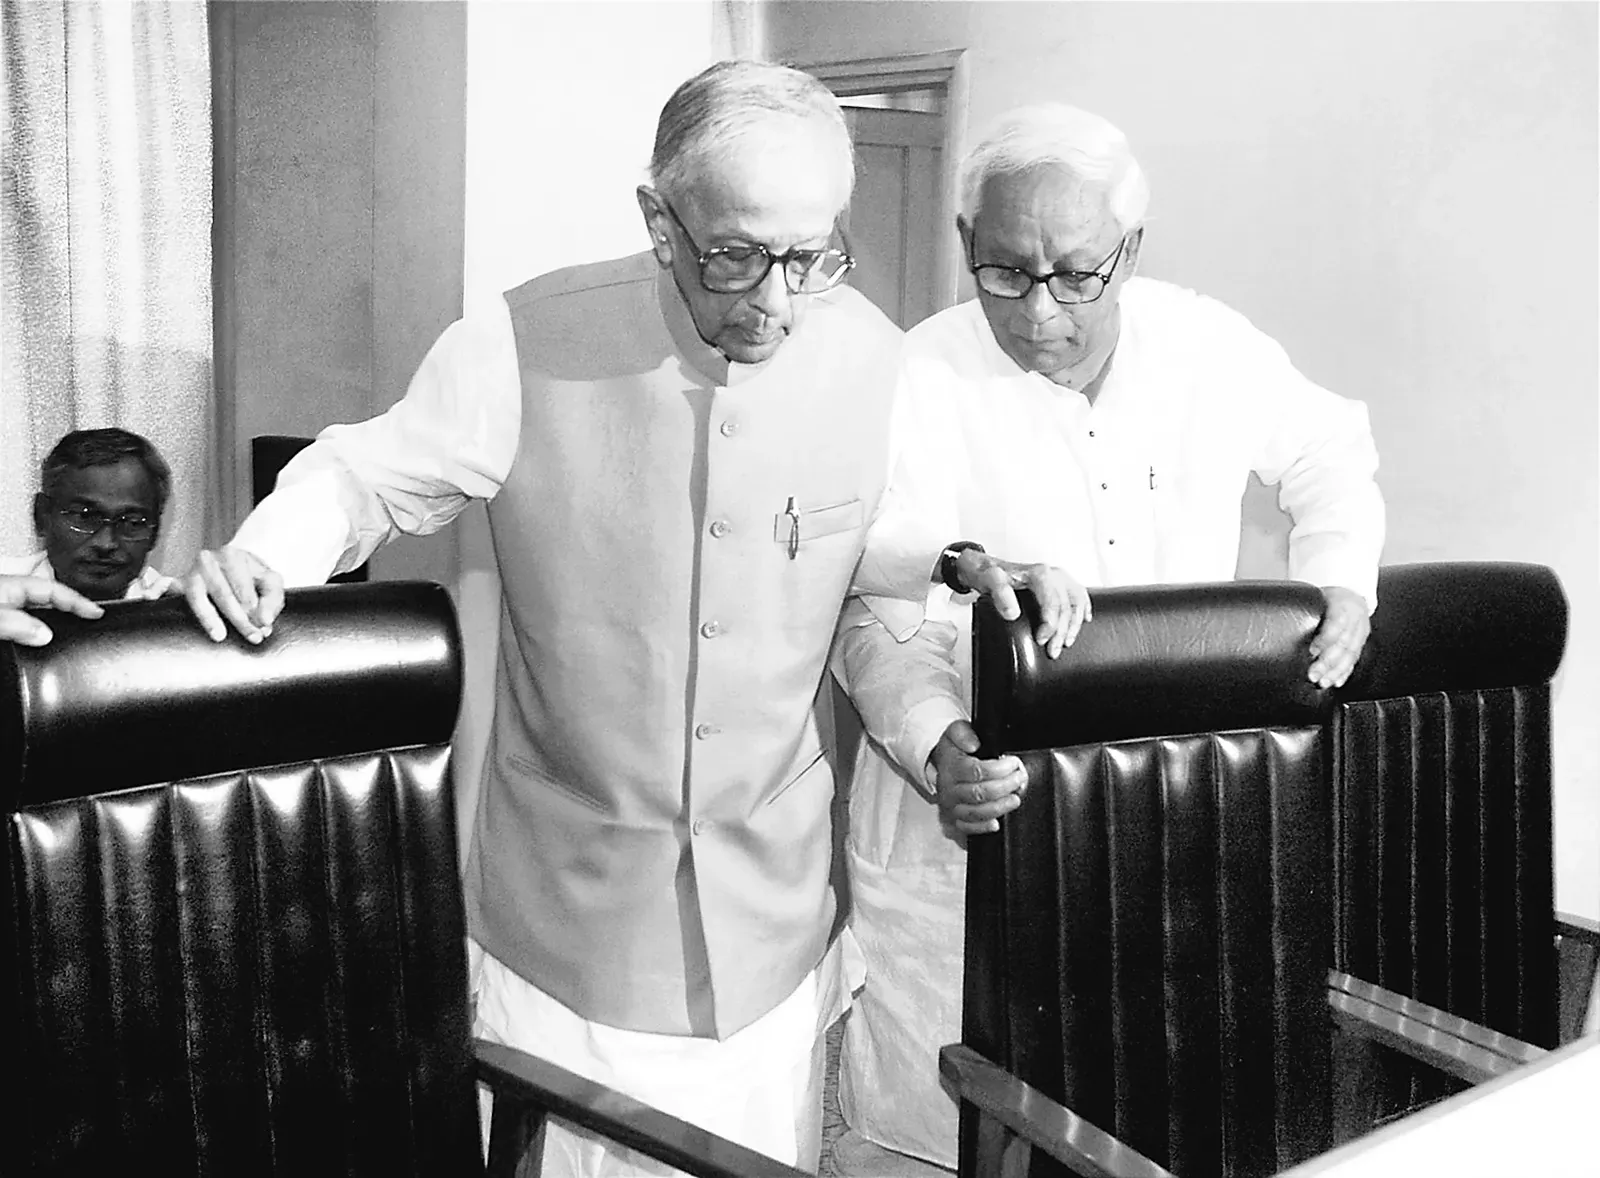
[232,301,522,586]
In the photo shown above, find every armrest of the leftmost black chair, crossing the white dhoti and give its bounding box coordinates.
[472,1039,808,1178]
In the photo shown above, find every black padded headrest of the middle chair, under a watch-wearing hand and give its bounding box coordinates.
[973,581,1331,752]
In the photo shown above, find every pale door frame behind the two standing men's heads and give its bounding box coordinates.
[797,50,970,311]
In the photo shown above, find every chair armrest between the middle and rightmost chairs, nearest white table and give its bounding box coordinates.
[1328,970,1546,1084]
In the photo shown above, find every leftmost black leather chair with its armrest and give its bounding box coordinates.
[0,583,798,1178]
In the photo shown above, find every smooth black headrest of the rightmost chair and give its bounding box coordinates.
[1331,562,1566,701]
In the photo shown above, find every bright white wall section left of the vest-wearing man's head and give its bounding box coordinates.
[456,0,730,850]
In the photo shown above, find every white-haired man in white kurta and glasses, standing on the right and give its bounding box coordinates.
[837,106,1384,1167]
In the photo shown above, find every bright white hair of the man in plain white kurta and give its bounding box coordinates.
[962,102,1150,234]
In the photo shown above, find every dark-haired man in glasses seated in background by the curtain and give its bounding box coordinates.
[0,427,174,602]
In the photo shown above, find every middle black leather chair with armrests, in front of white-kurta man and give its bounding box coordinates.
[941,566,1568,1178]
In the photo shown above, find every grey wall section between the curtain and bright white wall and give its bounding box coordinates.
[211,0,467,584]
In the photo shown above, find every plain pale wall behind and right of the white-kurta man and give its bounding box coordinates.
[766,0,1600,917]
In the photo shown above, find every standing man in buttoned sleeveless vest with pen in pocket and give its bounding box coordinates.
[186,62,1088,1175]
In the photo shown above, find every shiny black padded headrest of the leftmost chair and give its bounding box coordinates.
[0,581,461,808]
